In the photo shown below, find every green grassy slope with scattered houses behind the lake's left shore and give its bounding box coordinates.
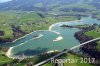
[0,11,77,38]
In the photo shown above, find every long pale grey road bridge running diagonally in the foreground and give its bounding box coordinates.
[34,37,100,66]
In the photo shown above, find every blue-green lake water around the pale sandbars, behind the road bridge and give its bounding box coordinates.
[0,17,100,56]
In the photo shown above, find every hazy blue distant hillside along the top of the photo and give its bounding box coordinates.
[0,0,100,11]
